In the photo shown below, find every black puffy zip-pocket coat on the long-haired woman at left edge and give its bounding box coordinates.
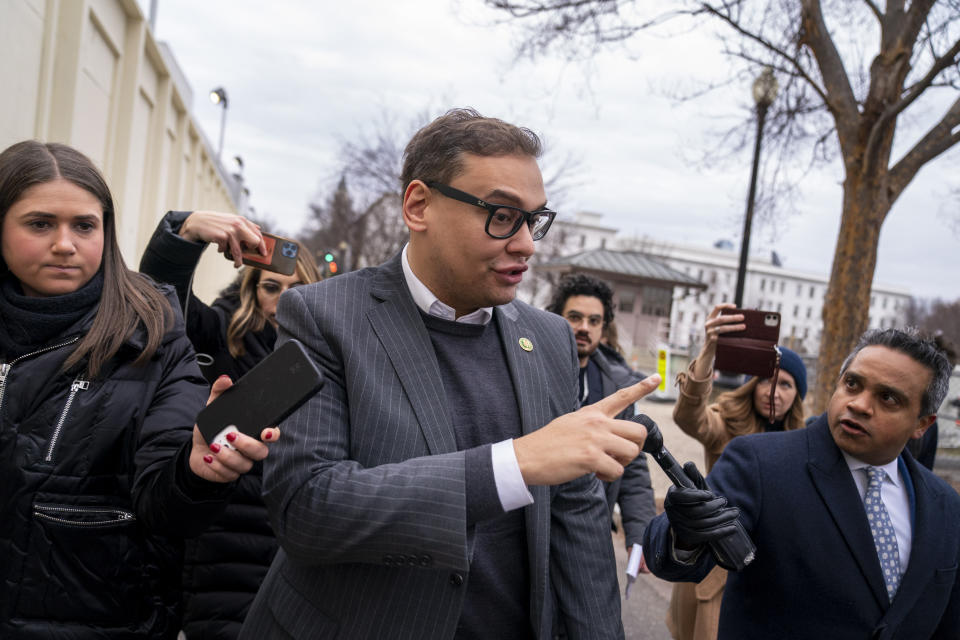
[0,288,227,640]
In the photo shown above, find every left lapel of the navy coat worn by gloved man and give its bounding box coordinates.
[806,415,889,610]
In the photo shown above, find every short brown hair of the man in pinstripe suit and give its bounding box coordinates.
[400,108,543,192]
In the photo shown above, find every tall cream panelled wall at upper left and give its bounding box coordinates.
[0,0,236,300]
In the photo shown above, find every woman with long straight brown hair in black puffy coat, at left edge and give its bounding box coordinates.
[0,141,279,640]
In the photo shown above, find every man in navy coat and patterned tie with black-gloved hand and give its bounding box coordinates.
[644,329,960,640]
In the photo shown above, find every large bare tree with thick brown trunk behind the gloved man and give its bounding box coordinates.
[485,0,960,410]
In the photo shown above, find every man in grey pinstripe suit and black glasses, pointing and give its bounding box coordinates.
[241,109,659,640]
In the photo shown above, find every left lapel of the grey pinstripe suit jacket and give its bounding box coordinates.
[367,255,457,455]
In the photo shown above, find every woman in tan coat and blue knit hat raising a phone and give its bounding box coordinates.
[667,303,807,640]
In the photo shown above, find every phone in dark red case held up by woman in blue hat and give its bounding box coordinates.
[713,309,780,378]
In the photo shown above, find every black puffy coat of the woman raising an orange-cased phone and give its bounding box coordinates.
[140,212,279,640]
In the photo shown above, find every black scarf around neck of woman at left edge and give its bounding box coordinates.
[0,271,103,362]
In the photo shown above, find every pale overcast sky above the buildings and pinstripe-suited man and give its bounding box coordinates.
[148,0,960,300]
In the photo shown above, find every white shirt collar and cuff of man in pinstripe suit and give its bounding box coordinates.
[400,244,533,511]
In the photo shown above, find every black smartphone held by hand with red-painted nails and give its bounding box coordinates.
[197,340,323,449]
